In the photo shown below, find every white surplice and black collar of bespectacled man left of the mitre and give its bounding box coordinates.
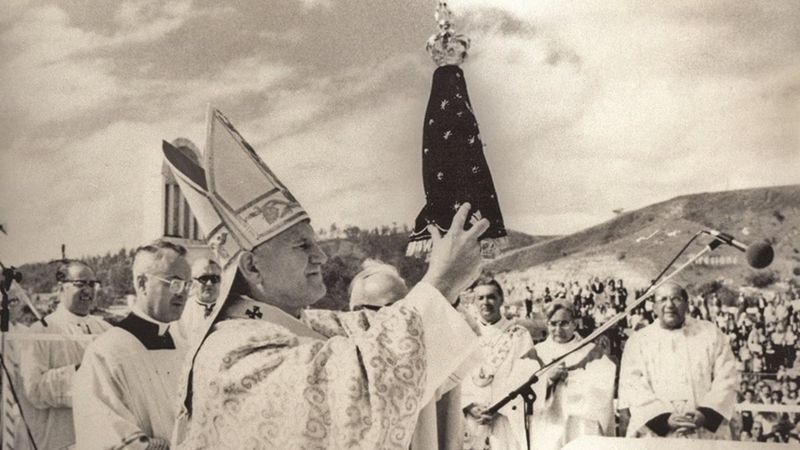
[74,312,188,450]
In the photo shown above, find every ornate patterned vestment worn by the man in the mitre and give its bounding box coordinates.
[173,283,475,450]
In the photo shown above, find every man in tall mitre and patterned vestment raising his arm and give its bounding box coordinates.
[164,109,488,450]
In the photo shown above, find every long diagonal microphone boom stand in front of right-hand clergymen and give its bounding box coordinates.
[486,231,724,418]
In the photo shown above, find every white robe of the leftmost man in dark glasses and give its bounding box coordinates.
[17,305,111,450]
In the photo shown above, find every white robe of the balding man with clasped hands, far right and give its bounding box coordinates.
[619,317,738,439]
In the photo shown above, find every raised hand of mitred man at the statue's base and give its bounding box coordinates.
[422,203,489,302]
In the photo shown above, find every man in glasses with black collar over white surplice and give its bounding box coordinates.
[74,241,191,450]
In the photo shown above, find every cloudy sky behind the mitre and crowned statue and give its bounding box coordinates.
[0,0,800,265]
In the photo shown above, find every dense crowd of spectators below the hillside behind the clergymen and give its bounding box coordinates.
[490,274,800,442]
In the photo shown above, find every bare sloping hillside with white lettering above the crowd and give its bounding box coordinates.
[489,185,800,283]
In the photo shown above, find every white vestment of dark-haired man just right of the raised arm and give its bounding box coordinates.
[461,318,539,450]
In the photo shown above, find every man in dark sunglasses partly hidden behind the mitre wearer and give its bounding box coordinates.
[176,258,222,346]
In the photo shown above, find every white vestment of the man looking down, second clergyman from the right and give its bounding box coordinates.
[530,334,616,450]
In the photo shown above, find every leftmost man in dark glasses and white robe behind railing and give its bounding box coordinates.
[19,261,111,450]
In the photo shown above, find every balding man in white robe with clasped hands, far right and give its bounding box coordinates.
[619,282,738,439]
